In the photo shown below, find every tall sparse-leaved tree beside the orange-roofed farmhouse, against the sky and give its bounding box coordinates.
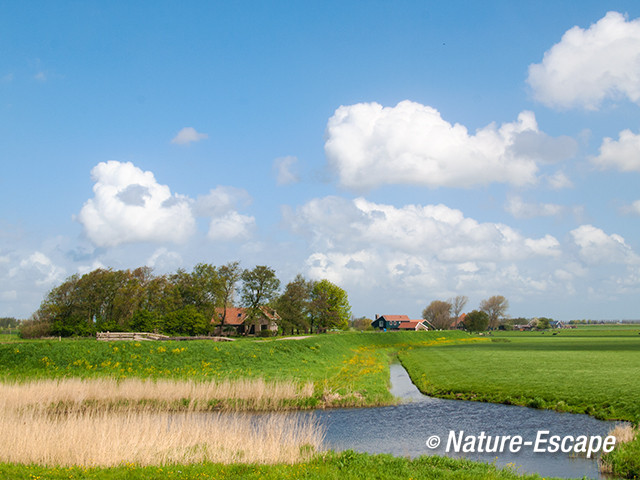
[241,265,280,330]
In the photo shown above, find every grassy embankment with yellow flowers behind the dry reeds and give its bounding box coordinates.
[0,332,483,410]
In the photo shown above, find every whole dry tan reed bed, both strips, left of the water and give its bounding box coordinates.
[0,379,324,466]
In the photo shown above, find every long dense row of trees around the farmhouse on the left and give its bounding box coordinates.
[20,262,351,338]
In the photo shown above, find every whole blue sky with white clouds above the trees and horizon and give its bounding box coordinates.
[0,0,640,320]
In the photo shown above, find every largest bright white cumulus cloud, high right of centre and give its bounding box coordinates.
[325,100,575,190]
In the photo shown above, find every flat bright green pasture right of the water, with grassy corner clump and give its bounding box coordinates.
[399,327,640,478]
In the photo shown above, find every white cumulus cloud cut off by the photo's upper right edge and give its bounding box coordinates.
[527,12,640,110]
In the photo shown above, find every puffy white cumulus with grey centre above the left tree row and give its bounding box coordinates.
[77,160,195,247]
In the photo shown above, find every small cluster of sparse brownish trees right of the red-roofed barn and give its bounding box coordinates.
[422,295,509,332]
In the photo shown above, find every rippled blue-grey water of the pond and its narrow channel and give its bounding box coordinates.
[311,364,615,479]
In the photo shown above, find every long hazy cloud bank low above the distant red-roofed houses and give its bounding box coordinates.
[285,196,562,298]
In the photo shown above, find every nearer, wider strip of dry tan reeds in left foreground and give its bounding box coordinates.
[0,411,324,467]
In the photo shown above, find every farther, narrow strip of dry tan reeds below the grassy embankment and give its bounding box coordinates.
[0,378,314,410]
